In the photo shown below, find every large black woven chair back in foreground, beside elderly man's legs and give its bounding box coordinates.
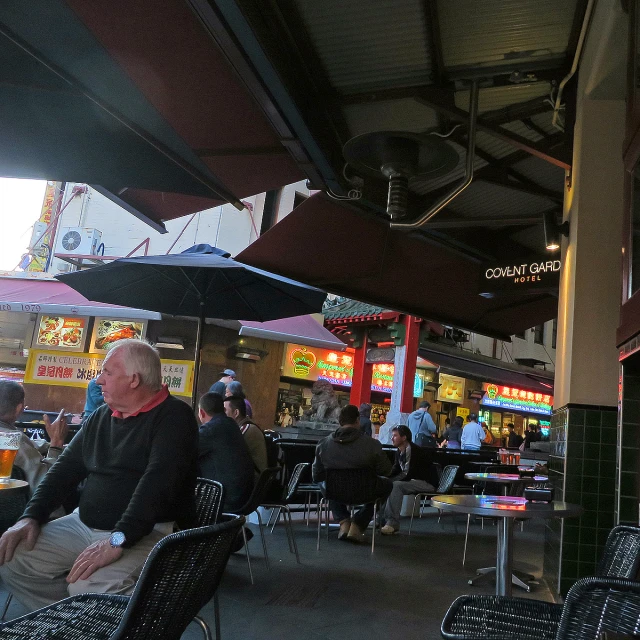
[111,516,245,640]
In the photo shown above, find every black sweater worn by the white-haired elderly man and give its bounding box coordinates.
[23,396,198,547]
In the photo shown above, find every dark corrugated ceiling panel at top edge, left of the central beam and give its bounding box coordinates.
[297,0,431,93]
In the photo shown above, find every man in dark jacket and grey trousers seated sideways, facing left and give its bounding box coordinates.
[382,424,438,536]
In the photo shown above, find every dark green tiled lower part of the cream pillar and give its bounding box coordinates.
[544,405,616,595]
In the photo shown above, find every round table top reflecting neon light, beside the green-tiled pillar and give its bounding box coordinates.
[431,495,583,518]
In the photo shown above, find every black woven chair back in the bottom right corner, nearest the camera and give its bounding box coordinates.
[556,578,640,640]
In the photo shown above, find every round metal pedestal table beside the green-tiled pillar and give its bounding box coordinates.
[431,495,583,596]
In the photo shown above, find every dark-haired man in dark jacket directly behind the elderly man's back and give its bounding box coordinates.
[198,393,254,513]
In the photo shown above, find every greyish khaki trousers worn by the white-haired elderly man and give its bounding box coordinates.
[0,511,173,611]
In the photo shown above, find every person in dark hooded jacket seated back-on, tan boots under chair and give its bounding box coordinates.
[312,404,391,542]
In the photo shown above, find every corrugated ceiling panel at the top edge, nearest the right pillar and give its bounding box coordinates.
[438,0,576,69]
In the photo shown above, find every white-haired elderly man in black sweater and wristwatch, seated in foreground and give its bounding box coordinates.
[0,340,198,609]
